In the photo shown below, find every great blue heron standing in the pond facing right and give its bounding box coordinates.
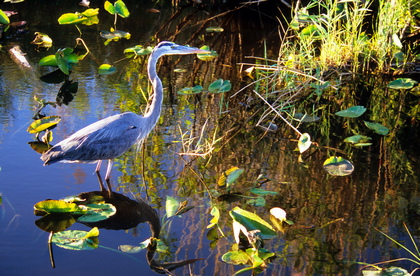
[41,41,210,195]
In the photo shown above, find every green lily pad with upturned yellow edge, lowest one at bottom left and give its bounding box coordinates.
[52,227,99,250]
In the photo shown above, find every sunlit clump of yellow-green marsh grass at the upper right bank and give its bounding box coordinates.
[235,0,418,140]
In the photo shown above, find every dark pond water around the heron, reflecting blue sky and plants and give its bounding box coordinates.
[0,1,420,275]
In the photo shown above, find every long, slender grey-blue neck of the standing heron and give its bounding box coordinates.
[144,53,163,132]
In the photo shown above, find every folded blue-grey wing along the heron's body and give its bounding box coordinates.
[41,112,144,164]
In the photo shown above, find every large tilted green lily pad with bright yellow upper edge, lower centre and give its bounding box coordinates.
[229,207,277,239]
